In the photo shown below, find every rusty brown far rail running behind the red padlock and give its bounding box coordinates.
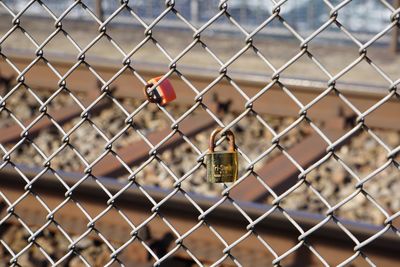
[0,50,400,130]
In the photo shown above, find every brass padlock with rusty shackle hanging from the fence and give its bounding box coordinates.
[206,128,238,183]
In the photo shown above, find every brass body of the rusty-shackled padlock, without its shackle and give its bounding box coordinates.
[206,151,238,183]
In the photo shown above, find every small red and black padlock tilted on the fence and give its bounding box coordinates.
[144,76,176,106]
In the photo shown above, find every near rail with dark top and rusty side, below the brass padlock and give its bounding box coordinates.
[0,166,400,266]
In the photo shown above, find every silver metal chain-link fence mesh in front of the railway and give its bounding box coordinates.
[0,0,400,266]
